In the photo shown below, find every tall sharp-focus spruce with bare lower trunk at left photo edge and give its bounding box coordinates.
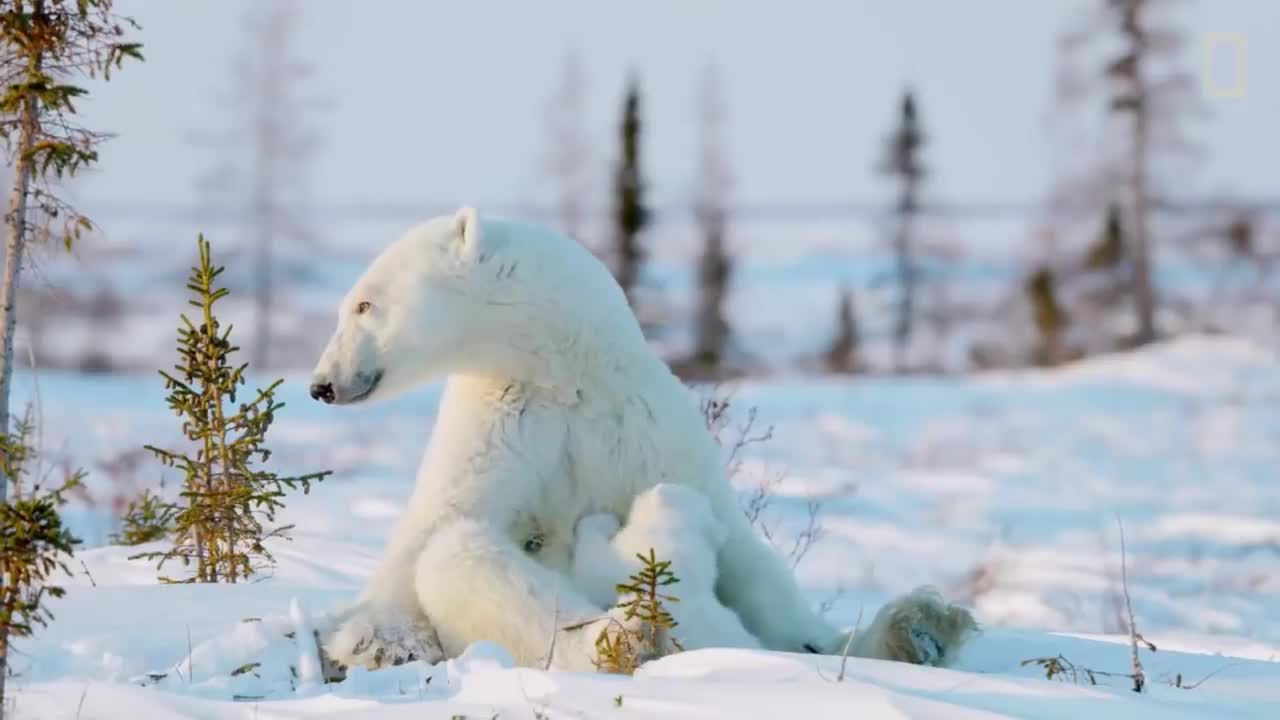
[0,0,142,707]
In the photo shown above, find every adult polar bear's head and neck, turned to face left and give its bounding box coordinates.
[311,208,644,405]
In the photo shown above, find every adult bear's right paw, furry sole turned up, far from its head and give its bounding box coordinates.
[854,587,978,667]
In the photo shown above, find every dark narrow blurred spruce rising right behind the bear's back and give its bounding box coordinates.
[613,76,649,306]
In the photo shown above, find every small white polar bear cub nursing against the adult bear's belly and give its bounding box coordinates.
[573,483,760,650]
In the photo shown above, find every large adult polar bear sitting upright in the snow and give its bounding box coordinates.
[310,208,973,670]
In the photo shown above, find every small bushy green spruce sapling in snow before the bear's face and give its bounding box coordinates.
[137,236,330,583]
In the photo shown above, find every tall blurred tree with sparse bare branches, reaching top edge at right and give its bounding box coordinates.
[1055,0,1202,346]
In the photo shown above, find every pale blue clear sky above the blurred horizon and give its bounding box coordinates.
[77,0,1280,217]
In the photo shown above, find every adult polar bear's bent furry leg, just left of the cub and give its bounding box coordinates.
[415,518,616,670]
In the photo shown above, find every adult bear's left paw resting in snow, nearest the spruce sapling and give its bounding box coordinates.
[324,605,444,670]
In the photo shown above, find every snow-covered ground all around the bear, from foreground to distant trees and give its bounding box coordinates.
[2,338,1280,720]
